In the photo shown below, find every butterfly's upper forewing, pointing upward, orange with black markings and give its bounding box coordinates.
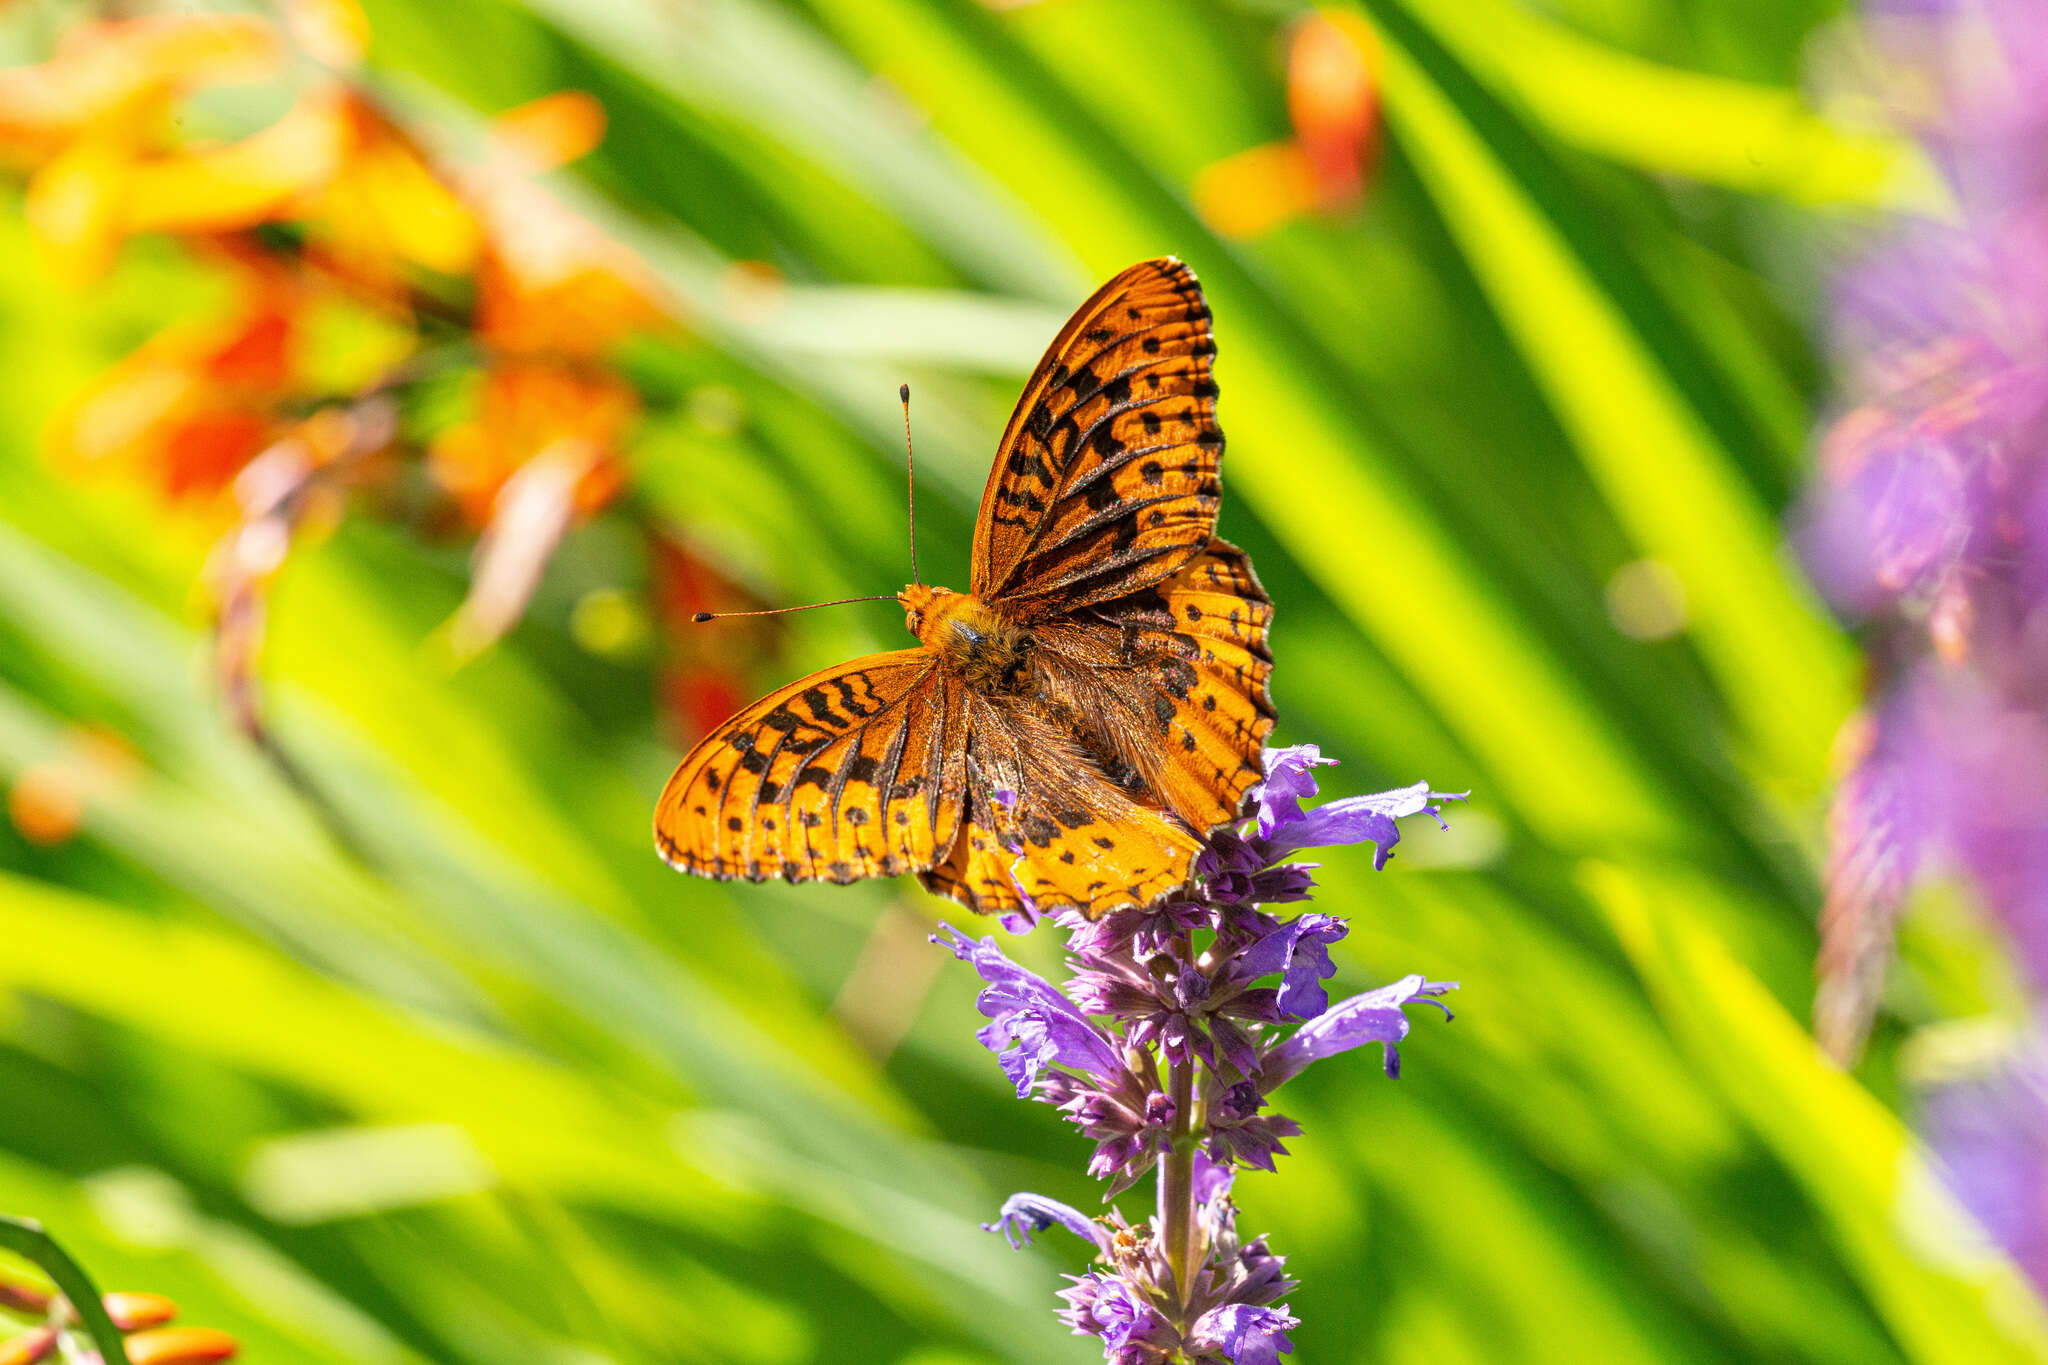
[973,258,1223,620]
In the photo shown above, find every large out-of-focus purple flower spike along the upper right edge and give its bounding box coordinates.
[1798,0,2048,1058]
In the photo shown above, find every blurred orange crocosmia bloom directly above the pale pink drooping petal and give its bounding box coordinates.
[428,360,639,526]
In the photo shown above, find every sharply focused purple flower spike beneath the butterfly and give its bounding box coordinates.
[932,745,1458,1365]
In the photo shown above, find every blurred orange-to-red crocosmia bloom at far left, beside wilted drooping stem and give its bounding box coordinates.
[45,261,301,497]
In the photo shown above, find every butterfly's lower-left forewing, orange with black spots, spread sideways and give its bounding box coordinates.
[653,649,967,882]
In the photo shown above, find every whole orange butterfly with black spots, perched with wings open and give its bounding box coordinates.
[655,258,1274,919]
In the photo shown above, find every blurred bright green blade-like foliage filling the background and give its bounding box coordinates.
[0,0,2048,1365]
